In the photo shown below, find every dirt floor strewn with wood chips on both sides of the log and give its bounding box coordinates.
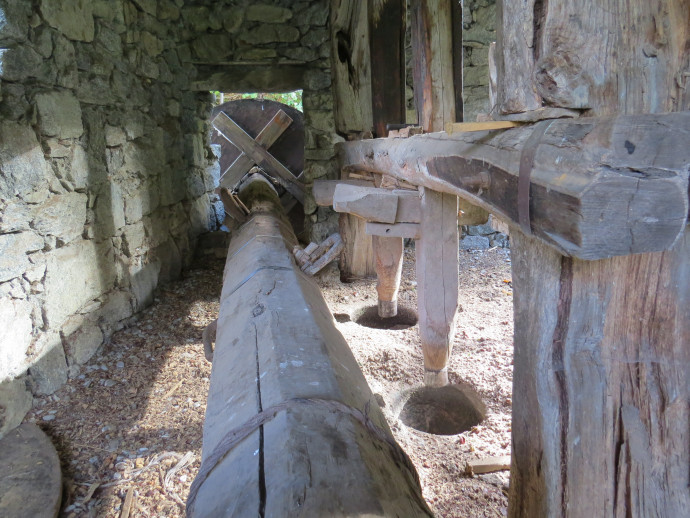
[27,248,512,518]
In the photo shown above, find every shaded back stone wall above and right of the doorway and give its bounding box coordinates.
[181,0,342,244]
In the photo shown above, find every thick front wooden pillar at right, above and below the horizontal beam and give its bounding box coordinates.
[497,0,690,518]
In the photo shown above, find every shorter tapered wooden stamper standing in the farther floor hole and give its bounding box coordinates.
[372,236,403,318]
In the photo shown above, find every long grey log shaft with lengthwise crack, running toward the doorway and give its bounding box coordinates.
[187,177,431,518]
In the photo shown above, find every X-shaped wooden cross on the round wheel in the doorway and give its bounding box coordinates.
[212,110,304,204]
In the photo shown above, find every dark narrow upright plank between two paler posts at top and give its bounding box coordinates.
[369,0,406,137]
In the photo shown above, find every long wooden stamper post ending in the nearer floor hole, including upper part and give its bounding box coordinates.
[410,0,459,386]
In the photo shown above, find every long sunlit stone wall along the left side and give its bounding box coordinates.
[0,0,217,435]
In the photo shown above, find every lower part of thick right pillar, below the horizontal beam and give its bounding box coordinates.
[510,229,690,518]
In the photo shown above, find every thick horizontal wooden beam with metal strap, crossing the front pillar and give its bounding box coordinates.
[337,112,690,260]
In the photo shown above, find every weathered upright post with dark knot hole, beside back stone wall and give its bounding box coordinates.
[330,0,373,135]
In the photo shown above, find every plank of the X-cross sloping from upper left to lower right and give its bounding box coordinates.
[212,112,304,204]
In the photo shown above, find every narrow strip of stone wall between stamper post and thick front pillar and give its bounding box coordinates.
[462,0,496,122]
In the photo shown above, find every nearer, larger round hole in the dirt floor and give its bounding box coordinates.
[399,385,486,435]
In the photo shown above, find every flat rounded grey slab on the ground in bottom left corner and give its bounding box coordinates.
[0,423,62,518]
